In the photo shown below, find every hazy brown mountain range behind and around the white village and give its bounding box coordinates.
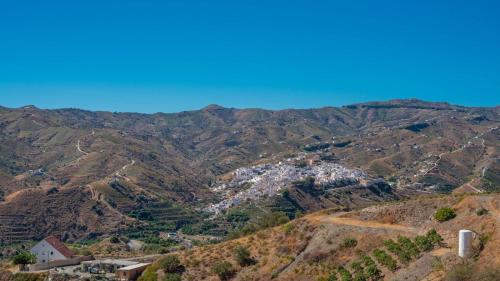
[0,100,500,242]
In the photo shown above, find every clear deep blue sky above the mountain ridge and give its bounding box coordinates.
[0,0,500,112]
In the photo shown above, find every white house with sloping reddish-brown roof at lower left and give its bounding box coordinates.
[31,236,74,264]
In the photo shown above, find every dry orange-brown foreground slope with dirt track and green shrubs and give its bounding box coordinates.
[148,192,500,281]
